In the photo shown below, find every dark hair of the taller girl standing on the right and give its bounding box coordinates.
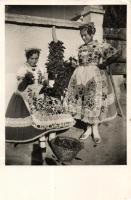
[80,22,96,35]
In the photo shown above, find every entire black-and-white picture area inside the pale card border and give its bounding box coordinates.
[5,4,127,167]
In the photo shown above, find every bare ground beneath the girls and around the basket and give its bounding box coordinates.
[6,109,126,165]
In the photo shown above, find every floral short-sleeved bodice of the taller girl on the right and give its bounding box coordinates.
[78,40,117,65]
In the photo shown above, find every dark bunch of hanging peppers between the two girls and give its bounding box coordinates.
[46,40,74,98]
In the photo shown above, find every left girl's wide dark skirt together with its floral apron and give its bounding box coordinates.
[6,87,75,142]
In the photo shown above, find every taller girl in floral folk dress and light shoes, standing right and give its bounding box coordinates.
[66,22,118,143]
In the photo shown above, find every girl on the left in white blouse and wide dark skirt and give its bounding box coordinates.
[6,48,74,143]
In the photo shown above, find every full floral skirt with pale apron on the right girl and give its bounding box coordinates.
[65,65,117,124]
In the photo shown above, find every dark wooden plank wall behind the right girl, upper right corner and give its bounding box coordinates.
[103,5,127,75]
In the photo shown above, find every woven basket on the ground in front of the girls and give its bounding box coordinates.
[51,136,82,161]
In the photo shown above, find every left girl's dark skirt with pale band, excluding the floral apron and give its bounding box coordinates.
[5,93,72,143]
